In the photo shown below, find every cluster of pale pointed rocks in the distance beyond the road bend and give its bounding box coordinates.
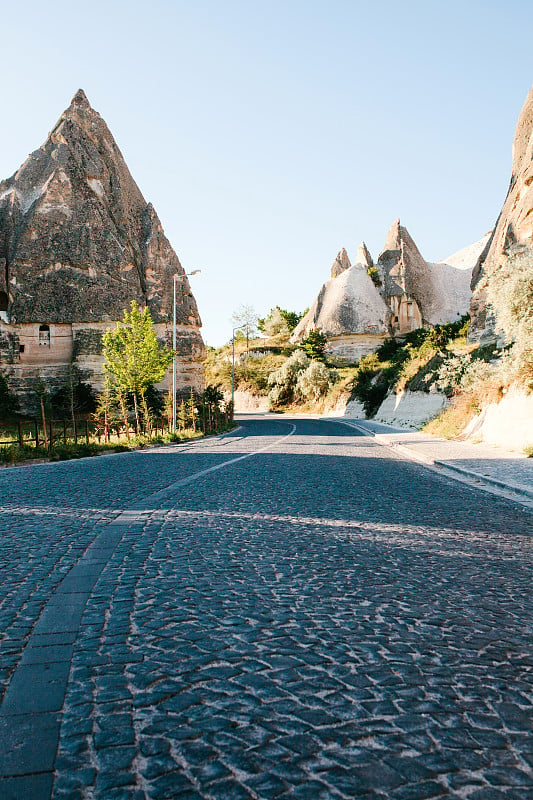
[291,220,490,360]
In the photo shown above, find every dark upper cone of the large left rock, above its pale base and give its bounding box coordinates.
[0,89,200,338]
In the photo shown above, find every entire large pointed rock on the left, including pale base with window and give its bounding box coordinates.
[0,89,204,410]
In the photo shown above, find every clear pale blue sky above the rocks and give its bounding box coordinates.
[0,0,533,345]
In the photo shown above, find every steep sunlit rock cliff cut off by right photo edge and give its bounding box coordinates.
[469,88,533,342]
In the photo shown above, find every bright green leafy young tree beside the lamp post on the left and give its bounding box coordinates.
[102,300,174,433]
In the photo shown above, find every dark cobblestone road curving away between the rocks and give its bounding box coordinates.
[0,418,533,800]
